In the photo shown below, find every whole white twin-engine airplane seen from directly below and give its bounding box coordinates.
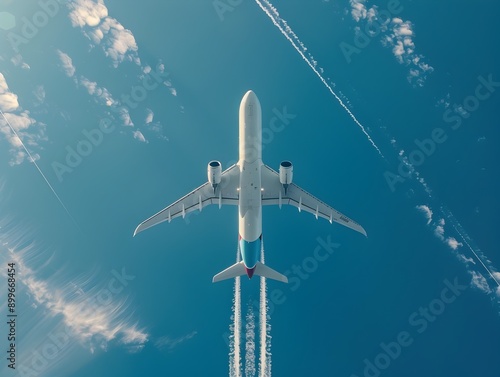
[134,90,366,283]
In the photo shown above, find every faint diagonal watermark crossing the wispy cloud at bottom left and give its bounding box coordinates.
[18,268,135,377]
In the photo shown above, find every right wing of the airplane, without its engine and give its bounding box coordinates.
[262,165,366,236]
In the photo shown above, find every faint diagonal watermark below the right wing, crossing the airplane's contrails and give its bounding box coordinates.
[222,235,340,347]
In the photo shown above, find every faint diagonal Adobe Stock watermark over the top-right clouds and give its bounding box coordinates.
[339,0,404,64]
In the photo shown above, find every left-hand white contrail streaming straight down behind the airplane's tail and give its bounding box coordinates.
[229,246,241,377]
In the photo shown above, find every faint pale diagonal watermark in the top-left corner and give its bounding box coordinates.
[0,0,68,52]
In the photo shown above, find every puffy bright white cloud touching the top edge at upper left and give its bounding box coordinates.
[68,0,141,67]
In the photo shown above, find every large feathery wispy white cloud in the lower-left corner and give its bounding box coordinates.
[0,214,149,377]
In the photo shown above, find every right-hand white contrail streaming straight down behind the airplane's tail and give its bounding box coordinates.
[259,242,271,377]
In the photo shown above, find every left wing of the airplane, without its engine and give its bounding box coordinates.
[134,164,240,236]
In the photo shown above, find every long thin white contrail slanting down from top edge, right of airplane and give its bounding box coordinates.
[255,0,385,159]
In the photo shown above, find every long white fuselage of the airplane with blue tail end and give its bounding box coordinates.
[238,91,262,269]
